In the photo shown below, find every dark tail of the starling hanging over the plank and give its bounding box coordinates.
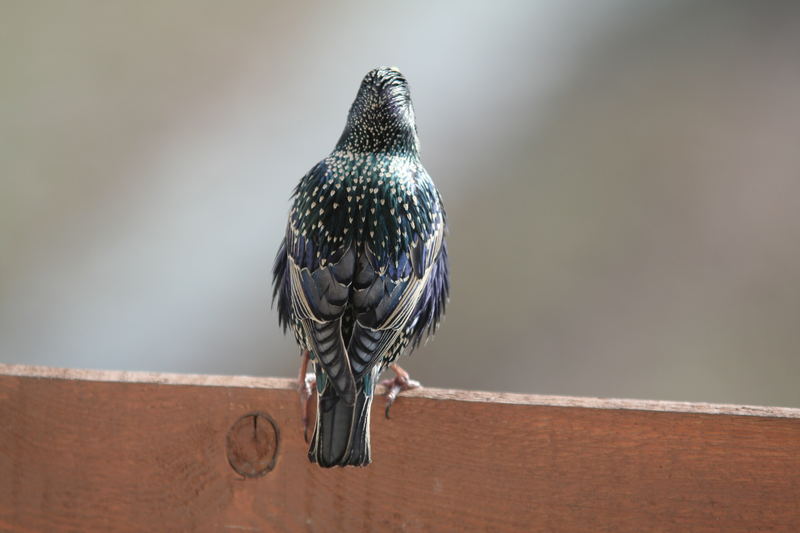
[308,371,378,467]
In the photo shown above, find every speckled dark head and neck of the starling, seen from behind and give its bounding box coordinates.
[337,67,419,154]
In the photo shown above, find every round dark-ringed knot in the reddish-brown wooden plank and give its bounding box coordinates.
[227,412,280,477]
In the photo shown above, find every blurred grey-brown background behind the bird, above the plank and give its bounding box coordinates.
[0,0,800,406]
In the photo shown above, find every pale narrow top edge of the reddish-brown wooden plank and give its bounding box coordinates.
[0,363,800,419]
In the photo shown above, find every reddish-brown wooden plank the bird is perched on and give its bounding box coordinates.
[0,365,800,532]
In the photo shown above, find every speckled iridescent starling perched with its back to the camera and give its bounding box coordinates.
[273,67,450,468]
